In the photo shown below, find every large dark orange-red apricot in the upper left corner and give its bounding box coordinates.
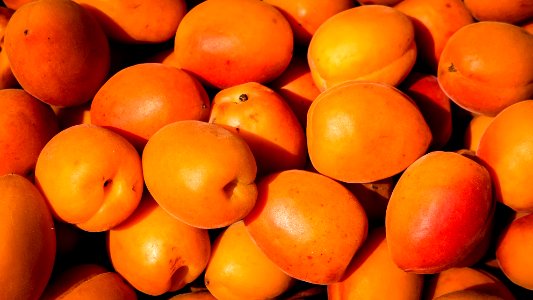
[4,0,110,106]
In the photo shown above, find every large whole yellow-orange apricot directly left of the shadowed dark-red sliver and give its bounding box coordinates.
[307,81,432,183]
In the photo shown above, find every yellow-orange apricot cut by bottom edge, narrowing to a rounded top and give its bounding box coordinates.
[204,221,294,299]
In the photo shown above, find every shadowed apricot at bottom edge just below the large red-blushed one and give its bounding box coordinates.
[425,267,515,300]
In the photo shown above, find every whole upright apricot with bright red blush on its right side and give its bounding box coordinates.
[385,151,495,273]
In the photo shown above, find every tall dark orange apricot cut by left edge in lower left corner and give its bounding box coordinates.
[0,174,56,299]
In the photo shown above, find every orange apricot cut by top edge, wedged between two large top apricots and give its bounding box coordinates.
[264,0,355,46]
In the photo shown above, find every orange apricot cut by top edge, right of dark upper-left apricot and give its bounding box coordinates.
[75,0,187,43]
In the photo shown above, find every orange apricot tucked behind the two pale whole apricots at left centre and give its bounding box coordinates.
[91,63,210,150]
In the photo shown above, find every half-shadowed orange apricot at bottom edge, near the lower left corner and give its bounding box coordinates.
[41,263,137,300]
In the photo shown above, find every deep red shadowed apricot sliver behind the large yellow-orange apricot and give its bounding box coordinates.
[400,72,452,149]
